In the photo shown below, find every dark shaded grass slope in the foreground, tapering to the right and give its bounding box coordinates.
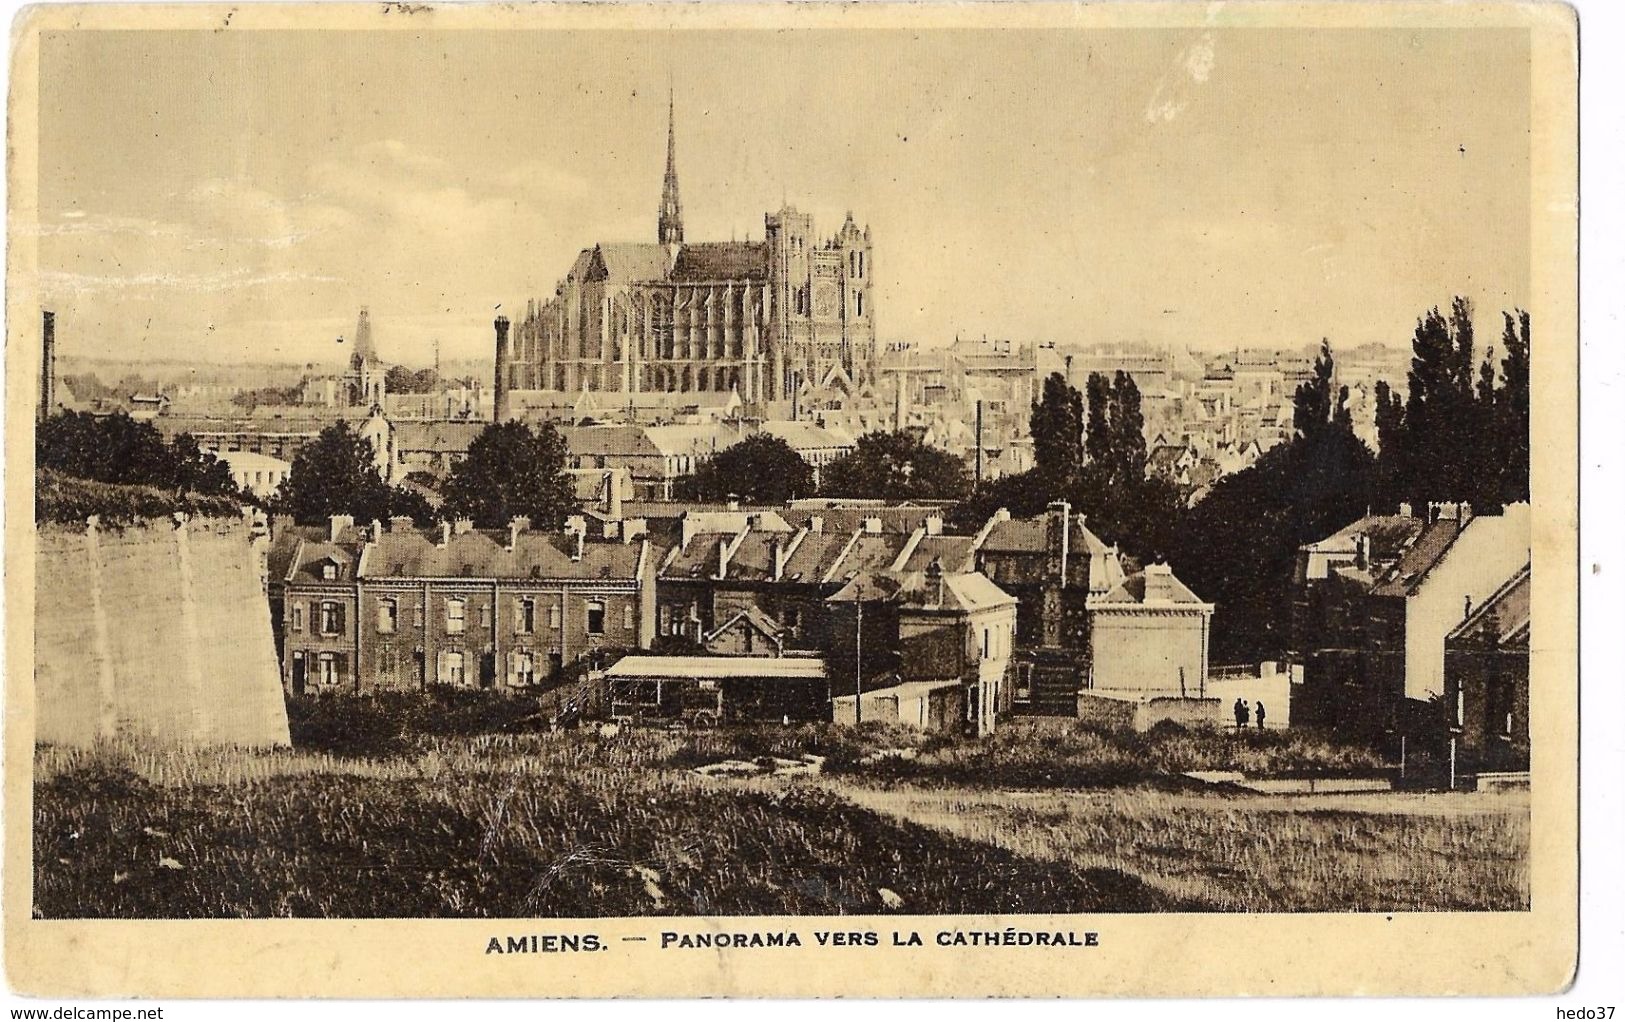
[34,733,1181,918]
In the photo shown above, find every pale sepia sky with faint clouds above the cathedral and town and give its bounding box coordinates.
[34,29,1529,364]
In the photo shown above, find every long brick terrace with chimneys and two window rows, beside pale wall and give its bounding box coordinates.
[280,517,655,694]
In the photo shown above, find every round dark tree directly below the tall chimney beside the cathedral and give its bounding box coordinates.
[445,421,580,530]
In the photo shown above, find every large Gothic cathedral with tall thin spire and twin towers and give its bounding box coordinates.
[496,94,876,419]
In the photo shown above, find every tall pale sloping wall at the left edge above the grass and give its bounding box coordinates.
[34,515,289,746]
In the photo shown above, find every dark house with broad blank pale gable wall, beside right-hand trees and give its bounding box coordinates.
[1292,504,1531,734]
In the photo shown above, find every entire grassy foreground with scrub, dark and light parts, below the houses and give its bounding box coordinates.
[34,695,1529,918]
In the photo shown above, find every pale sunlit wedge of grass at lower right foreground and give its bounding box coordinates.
[819,785,1529,912]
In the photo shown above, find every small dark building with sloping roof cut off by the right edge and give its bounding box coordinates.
[1445,564,1531,772]
